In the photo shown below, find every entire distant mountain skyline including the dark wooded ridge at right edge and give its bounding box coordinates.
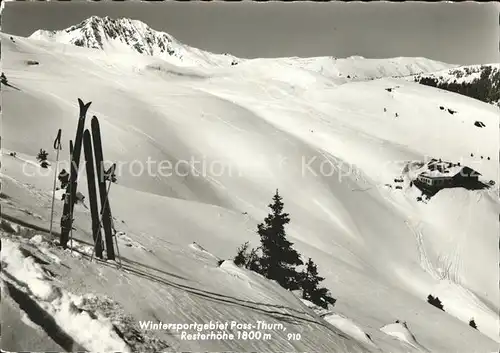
[30,16,500,105]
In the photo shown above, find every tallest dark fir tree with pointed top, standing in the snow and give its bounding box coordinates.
[257,190,303,290]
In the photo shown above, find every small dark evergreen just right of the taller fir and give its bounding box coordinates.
[300,258,336,309]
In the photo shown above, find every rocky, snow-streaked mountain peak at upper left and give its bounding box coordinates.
[30,16,239,66]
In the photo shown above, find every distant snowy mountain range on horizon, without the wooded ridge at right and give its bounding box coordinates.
[30,16,454,79]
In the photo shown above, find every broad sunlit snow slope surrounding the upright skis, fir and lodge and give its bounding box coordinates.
[1,30,500,353]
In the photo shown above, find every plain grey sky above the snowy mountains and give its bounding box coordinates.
[2,1,500,64]
